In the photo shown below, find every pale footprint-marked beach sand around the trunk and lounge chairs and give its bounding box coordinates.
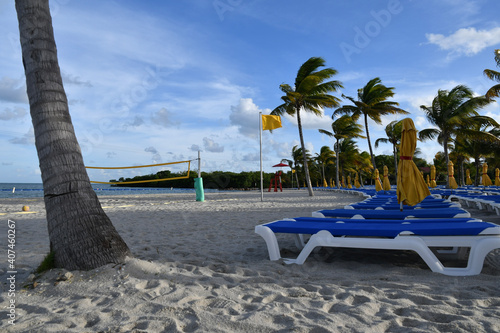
[0,191,500,333]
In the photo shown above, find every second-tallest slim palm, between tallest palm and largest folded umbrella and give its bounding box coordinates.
[335,77,409,169]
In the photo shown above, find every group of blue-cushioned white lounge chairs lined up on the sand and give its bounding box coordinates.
[255,192,500,276]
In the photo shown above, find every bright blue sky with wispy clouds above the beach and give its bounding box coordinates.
[0,0,500,182]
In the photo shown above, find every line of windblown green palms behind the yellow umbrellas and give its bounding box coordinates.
[271,50,500,196]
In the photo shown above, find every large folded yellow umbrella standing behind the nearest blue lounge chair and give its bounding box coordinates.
[396,118,431,206]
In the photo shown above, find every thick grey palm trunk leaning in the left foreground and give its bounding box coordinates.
[16,0,130,270]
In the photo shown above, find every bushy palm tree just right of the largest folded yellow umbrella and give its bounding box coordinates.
[419,85,498,187]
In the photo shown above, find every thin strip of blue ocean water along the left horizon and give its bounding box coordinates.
[0,183,209,198]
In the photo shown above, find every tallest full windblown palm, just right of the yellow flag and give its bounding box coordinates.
[271,57,343,196]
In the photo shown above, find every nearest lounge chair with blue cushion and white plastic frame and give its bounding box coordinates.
[255,218,500,276]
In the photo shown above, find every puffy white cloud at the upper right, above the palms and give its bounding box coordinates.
[425,27,500,56]
